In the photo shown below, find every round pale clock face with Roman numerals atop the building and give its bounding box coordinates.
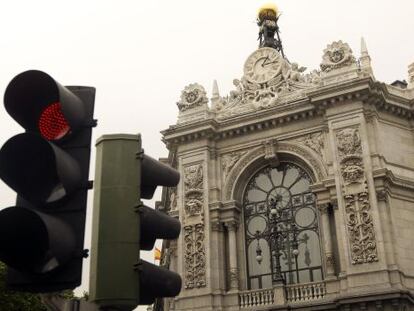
[244,47,282,83]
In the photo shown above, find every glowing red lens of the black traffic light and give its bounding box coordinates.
[39,103,70,140]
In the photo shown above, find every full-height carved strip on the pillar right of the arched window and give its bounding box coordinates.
[335,128,378,264]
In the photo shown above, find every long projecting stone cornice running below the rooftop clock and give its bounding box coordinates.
[161,77,414,148]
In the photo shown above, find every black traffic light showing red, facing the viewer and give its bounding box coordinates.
[0,70,96,292]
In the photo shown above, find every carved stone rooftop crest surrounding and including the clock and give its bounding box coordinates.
[215,48,321,119]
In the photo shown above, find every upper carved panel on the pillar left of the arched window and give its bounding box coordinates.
[184,164,204,216]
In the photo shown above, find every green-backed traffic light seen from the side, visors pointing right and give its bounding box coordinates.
[89,134,181,310]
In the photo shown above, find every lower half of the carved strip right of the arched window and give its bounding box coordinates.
[344,191,378,265]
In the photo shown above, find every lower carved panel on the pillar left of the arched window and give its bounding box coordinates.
[184,224,206,289]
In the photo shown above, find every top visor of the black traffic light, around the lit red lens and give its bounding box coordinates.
[4,70,85,141]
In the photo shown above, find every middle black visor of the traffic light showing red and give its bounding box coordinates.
[0,133,81,205]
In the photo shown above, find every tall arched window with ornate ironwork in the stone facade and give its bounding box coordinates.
[243,162,323,289]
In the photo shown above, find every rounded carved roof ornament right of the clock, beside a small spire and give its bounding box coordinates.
[320,40,356,72]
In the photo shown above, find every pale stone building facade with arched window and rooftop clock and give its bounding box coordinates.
[159,39,414,311]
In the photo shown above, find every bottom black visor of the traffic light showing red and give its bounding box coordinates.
[0,207,75,273]
